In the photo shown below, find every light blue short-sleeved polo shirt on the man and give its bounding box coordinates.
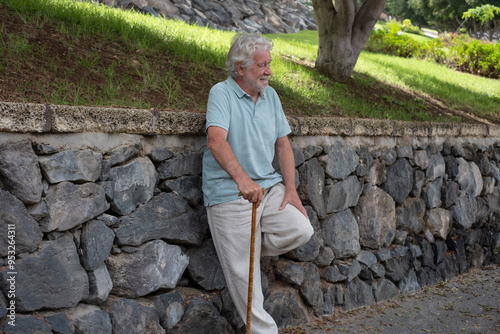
[202,77,291,206]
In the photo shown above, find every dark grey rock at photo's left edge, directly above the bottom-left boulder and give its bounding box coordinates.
[0,189,43,258]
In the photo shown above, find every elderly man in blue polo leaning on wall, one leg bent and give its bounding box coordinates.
[203,34,314,334]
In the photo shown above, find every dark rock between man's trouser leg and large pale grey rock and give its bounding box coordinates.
[186,239,226,291]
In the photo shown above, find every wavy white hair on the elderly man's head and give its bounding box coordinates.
[226,34,273,78]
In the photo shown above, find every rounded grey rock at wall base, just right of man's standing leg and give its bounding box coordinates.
[264,287,310,328]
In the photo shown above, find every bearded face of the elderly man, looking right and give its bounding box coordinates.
[238,50,272,95]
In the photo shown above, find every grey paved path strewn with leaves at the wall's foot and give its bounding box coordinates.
[280,265,500,334]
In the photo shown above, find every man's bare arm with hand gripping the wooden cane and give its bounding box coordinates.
[207,126,262,206]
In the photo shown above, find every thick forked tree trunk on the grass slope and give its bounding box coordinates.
[312,0,386,82]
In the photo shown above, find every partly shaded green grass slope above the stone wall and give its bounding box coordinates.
[0,0,500,122]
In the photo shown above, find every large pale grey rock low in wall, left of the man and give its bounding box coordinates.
[106,240,189,298]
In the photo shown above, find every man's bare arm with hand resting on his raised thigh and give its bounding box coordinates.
[275,136,307,217]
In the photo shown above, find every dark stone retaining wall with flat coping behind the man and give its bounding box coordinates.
[0,103,500,334]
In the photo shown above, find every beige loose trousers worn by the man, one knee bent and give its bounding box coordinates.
[207,183,314,334]
